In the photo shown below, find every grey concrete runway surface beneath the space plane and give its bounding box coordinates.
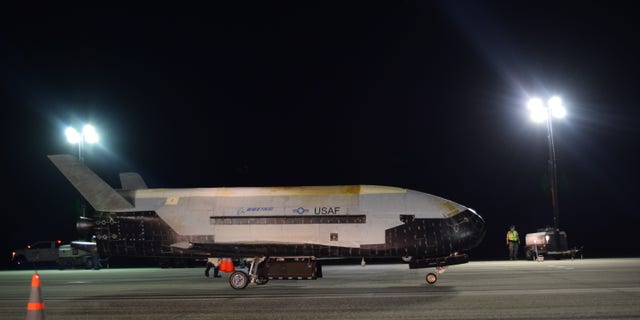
[0,259,640,320]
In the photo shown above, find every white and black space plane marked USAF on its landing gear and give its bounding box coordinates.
[48,155,485,289]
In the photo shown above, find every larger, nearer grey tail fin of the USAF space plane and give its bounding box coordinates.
[47,154,133,211]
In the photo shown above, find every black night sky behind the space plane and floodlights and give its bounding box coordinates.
[0,1,640,263]
